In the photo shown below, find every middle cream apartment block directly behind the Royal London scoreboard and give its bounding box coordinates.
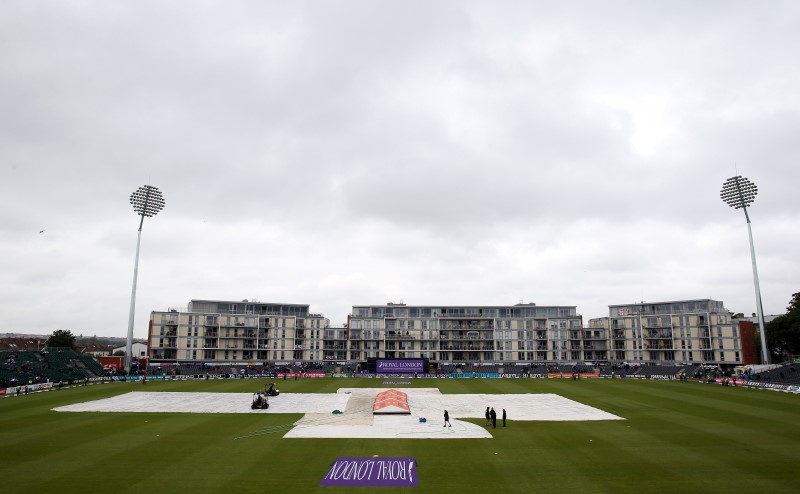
[344,303,608,364]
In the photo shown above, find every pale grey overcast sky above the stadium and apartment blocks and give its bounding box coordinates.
[0,0,800,338]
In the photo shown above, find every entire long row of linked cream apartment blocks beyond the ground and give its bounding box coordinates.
[148,299,752,365]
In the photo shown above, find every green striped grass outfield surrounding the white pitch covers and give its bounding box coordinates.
[0,379,800,494]
